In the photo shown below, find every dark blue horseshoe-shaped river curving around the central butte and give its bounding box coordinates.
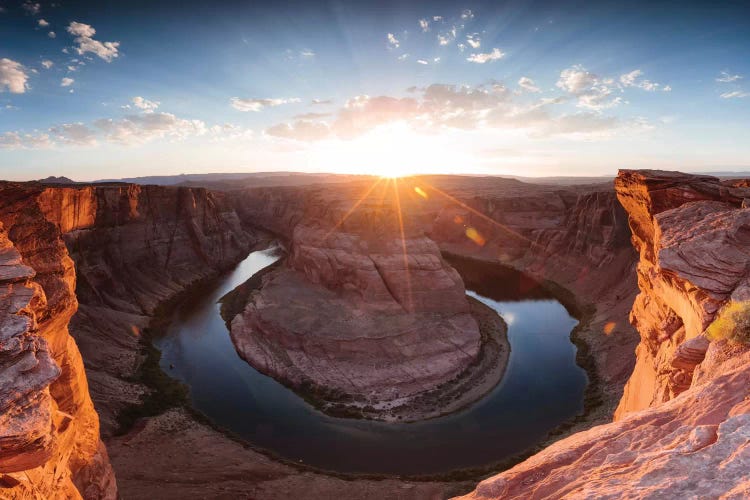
[155,249,587,474]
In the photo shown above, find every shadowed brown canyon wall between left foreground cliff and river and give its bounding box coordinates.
[38,184,256,436]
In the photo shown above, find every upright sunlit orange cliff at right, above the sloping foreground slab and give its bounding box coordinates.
[616,171,750,418]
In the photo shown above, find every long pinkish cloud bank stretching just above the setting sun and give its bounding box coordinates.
[266,82,653,142]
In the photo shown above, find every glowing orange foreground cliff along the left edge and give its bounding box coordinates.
[0,184,117,499]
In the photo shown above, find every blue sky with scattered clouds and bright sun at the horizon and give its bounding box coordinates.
[0,0,750,180]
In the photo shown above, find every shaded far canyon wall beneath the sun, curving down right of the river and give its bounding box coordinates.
[233,176,638,421]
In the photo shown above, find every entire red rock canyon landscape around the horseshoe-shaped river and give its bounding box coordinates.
[0,171,750,498]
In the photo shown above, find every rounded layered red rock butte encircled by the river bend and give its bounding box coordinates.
[231,182,480,410]
